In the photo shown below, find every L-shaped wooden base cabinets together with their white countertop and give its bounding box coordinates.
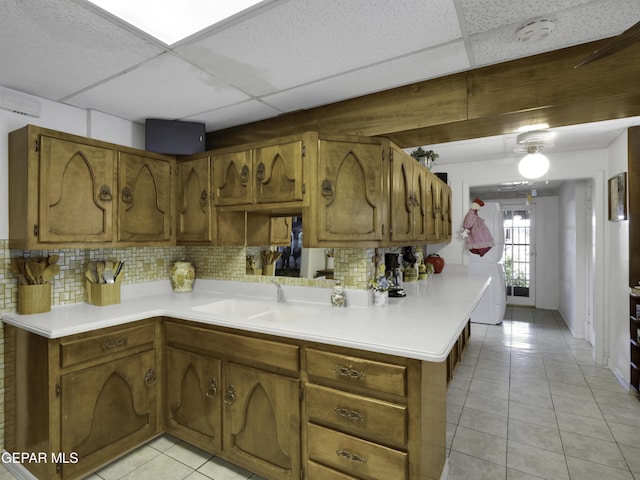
[4,266,490,480]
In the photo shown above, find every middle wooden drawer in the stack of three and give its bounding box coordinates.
[305,384,407,448]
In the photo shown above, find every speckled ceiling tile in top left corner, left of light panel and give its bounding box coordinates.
[0,0,162,100]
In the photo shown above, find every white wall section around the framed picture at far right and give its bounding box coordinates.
[606,132,630,382]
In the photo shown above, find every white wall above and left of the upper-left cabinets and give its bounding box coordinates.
[0,87,144,239]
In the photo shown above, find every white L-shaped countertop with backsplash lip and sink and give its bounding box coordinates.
[3,265,490,362]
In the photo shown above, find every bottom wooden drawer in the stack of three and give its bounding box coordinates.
[307,424,408,480]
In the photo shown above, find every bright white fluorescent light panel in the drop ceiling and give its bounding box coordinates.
[89,0,261,45]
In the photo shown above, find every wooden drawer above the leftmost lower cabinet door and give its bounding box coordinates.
[60,323,155,367]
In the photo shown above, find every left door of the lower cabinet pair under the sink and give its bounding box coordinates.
[165,347,222,452]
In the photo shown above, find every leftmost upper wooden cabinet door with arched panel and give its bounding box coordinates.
[34,136,115,243]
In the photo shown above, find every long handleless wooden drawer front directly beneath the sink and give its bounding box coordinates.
[165,322,300,375]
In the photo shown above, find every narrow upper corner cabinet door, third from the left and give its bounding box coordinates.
[176,157,213,243]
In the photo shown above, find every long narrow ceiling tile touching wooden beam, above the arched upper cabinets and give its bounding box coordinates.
[263,41,469,112]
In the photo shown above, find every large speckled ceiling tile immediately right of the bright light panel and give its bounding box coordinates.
[176,0,461,96]
